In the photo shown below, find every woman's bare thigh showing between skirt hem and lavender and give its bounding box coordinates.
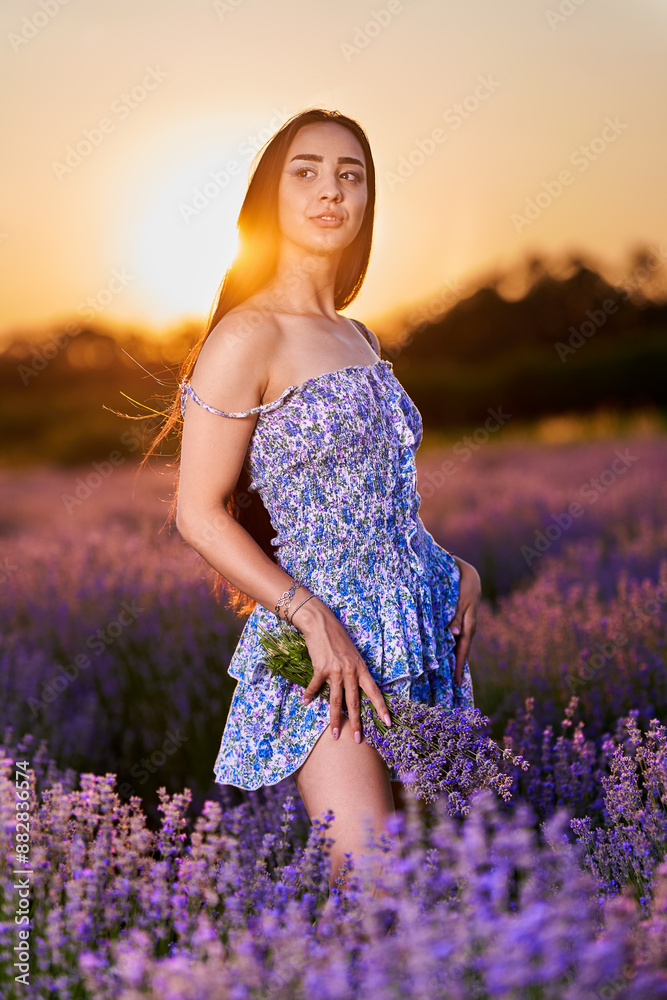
[293,715,394,888]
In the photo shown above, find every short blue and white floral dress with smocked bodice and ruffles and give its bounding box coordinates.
[180,321,473,789]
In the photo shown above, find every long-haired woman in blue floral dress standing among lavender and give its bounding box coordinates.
[156,109,481,885]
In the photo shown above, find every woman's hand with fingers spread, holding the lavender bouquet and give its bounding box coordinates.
[299,598,391,743]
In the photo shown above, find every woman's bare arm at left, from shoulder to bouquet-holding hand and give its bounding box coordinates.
[176,310,387,742]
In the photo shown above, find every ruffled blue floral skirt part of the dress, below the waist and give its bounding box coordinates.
[215,532,473,789]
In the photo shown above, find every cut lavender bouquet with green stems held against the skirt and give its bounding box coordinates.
[259,624,529,816]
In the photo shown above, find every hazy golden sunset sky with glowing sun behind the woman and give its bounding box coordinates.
[0,0,667,339]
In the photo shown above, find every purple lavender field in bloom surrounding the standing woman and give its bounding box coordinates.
[0,423,667,1000]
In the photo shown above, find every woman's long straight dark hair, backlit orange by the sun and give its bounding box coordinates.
[136,108,375,615]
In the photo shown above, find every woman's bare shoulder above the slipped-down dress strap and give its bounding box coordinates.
[191,303,277,411]
